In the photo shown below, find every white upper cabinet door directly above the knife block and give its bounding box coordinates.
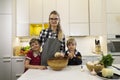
[89,0,105,22]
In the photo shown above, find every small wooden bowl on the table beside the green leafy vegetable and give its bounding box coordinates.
[86,62,104,73]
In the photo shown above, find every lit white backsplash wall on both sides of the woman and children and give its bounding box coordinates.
[14,36,107,56]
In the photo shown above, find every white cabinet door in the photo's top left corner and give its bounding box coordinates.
[0,0,12,14]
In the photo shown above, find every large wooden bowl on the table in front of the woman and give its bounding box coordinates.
[47,57,68,71]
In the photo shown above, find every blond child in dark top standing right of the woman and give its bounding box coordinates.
[65,38,82,65]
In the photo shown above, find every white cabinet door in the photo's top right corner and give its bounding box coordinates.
[106,0,120,13]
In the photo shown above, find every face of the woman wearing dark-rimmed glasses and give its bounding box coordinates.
[49,14,59,27]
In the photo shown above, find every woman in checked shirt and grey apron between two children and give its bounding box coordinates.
[39,11,65,65]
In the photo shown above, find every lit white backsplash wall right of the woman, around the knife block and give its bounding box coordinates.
[67,36,107,56]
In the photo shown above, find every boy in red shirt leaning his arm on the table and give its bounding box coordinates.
[24,38,47,71]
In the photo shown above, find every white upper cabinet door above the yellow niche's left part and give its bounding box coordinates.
[29,0,43,24]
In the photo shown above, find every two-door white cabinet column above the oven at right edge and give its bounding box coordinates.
[106,0,120,35]
